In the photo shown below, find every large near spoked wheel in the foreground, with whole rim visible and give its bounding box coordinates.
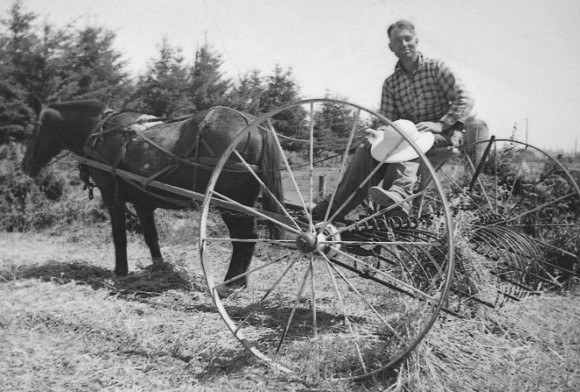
[200,99,454,379]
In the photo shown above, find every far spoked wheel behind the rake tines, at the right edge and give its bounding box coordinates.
[438,138,580,306]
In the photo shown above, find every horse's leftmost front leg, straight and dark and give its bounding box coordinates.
[101,191,129,276]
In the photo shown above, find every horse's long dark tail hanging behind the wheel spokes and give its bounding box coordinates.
[260,123,284,239]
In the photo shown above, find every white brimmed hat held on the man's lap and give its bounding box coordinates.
[369,120,435,163]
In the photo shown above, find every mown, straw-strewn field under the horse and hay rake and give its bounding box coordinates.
[0,214,580,391]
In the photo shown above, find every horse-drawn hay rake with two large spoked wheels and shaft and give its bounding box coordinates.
[67,99,580,379]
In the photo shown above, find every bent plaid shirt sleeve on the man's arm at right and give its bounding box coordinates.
[436,62,474,126]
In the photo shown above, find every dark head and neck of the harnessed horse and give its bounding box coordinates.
[22,98,104,177]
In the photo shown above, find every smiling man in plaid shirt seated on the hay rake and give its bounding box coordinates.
[312,20,473,218]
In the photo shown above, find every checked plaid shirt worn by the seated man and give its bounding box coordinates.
[380,53,473,127]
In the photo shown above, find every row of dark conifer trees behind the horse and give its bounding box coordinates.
[0,0,312,142]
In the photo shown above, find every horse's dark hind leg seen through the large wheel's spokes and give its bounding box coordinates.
[220,214,258,296]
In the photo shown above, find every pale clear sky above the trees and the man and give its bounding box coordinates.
[0,0,580,153]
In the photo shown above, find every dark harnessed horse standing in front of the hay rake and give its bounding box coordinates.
[22,100,283,292]
